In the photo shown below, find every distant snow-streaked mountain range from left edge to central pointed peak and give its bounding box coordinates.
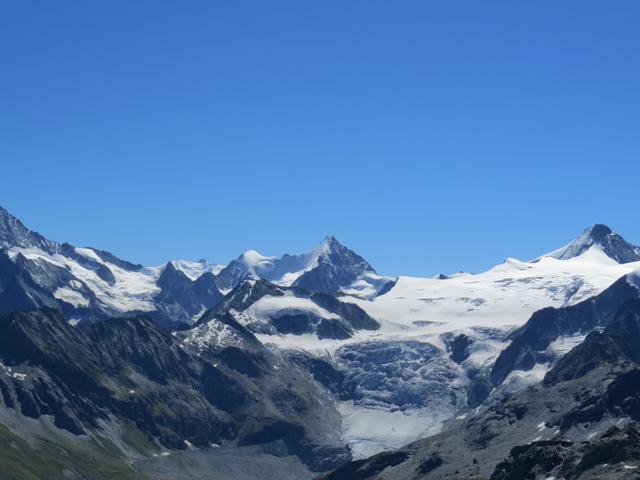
[0,208,392,328]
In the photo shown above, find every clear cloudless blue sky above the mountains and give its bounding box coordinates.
[0,0,640,275]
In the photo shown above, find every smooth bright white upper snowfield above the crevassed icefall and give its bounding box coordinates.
[344,246,640,337]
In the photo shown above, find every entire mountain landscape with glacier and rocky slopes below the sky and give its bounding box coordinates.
[0,204,640,480]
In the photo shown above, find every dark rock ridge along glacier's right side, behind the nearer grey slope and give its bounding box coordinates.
[491,276,640,385]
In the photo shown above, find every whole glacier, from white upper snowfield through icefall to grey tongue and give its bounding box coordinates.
[256,245,640,457]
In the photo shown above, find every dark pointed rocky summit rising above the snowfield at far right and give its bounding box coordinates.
[544,224,640,263]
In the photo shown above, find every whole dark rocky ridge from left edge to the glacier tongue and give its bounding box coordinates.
[0,310,348,469]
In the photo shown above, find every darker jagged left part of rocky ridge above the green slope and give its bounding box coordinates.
[0,311,239,448]
